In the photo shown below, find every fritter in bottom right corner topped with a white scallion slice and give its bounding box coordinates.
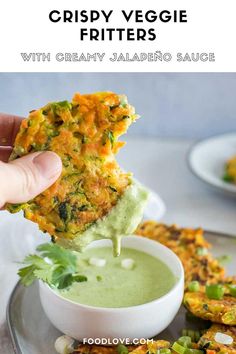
[198,324,236,354]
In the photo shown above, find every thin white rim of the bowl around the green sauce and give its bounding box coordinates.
[39,234,184,312]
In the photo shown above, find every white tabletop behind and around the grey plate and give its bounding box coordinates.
[0,139,236,354]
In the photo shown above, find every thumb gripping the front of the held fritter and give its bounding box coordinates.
[0,151,62,207]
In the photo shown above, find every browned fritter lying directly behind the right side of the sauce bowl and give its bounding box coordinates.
[136,221,225,287]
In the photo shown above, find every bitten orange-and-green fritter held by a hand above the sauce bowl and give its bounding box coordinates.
[7,92,137,240]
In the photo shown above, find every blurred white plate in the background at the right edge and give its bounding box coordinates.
[188,133,236,197]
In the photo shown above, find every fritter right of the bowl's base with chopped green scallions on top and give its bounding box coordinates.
[184,291,236,326]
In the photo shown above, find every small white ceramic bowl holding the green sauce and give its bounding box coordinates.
[40,236,184,341]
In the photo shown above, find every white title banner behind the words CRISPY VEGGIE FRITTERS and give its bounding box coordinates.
[0,0,236,72]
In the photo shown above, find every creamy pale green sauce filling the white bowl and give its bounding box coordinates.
[60,247,176,308]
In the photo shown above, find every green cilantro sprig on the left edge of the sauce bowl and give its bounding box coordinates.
[18,243,87,289]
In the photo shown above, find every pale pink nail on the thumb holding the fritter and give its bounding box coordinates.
[33,151,62,179]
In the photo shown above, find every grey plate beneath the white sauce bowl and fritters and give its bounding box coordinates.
[7,231,236,354]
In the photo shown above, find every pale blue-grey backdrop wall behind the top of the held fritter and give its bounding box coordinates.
[0,73,236,139]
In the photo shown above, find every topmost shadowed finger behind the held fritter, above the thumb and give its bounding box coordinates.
[0,113,23,146]
